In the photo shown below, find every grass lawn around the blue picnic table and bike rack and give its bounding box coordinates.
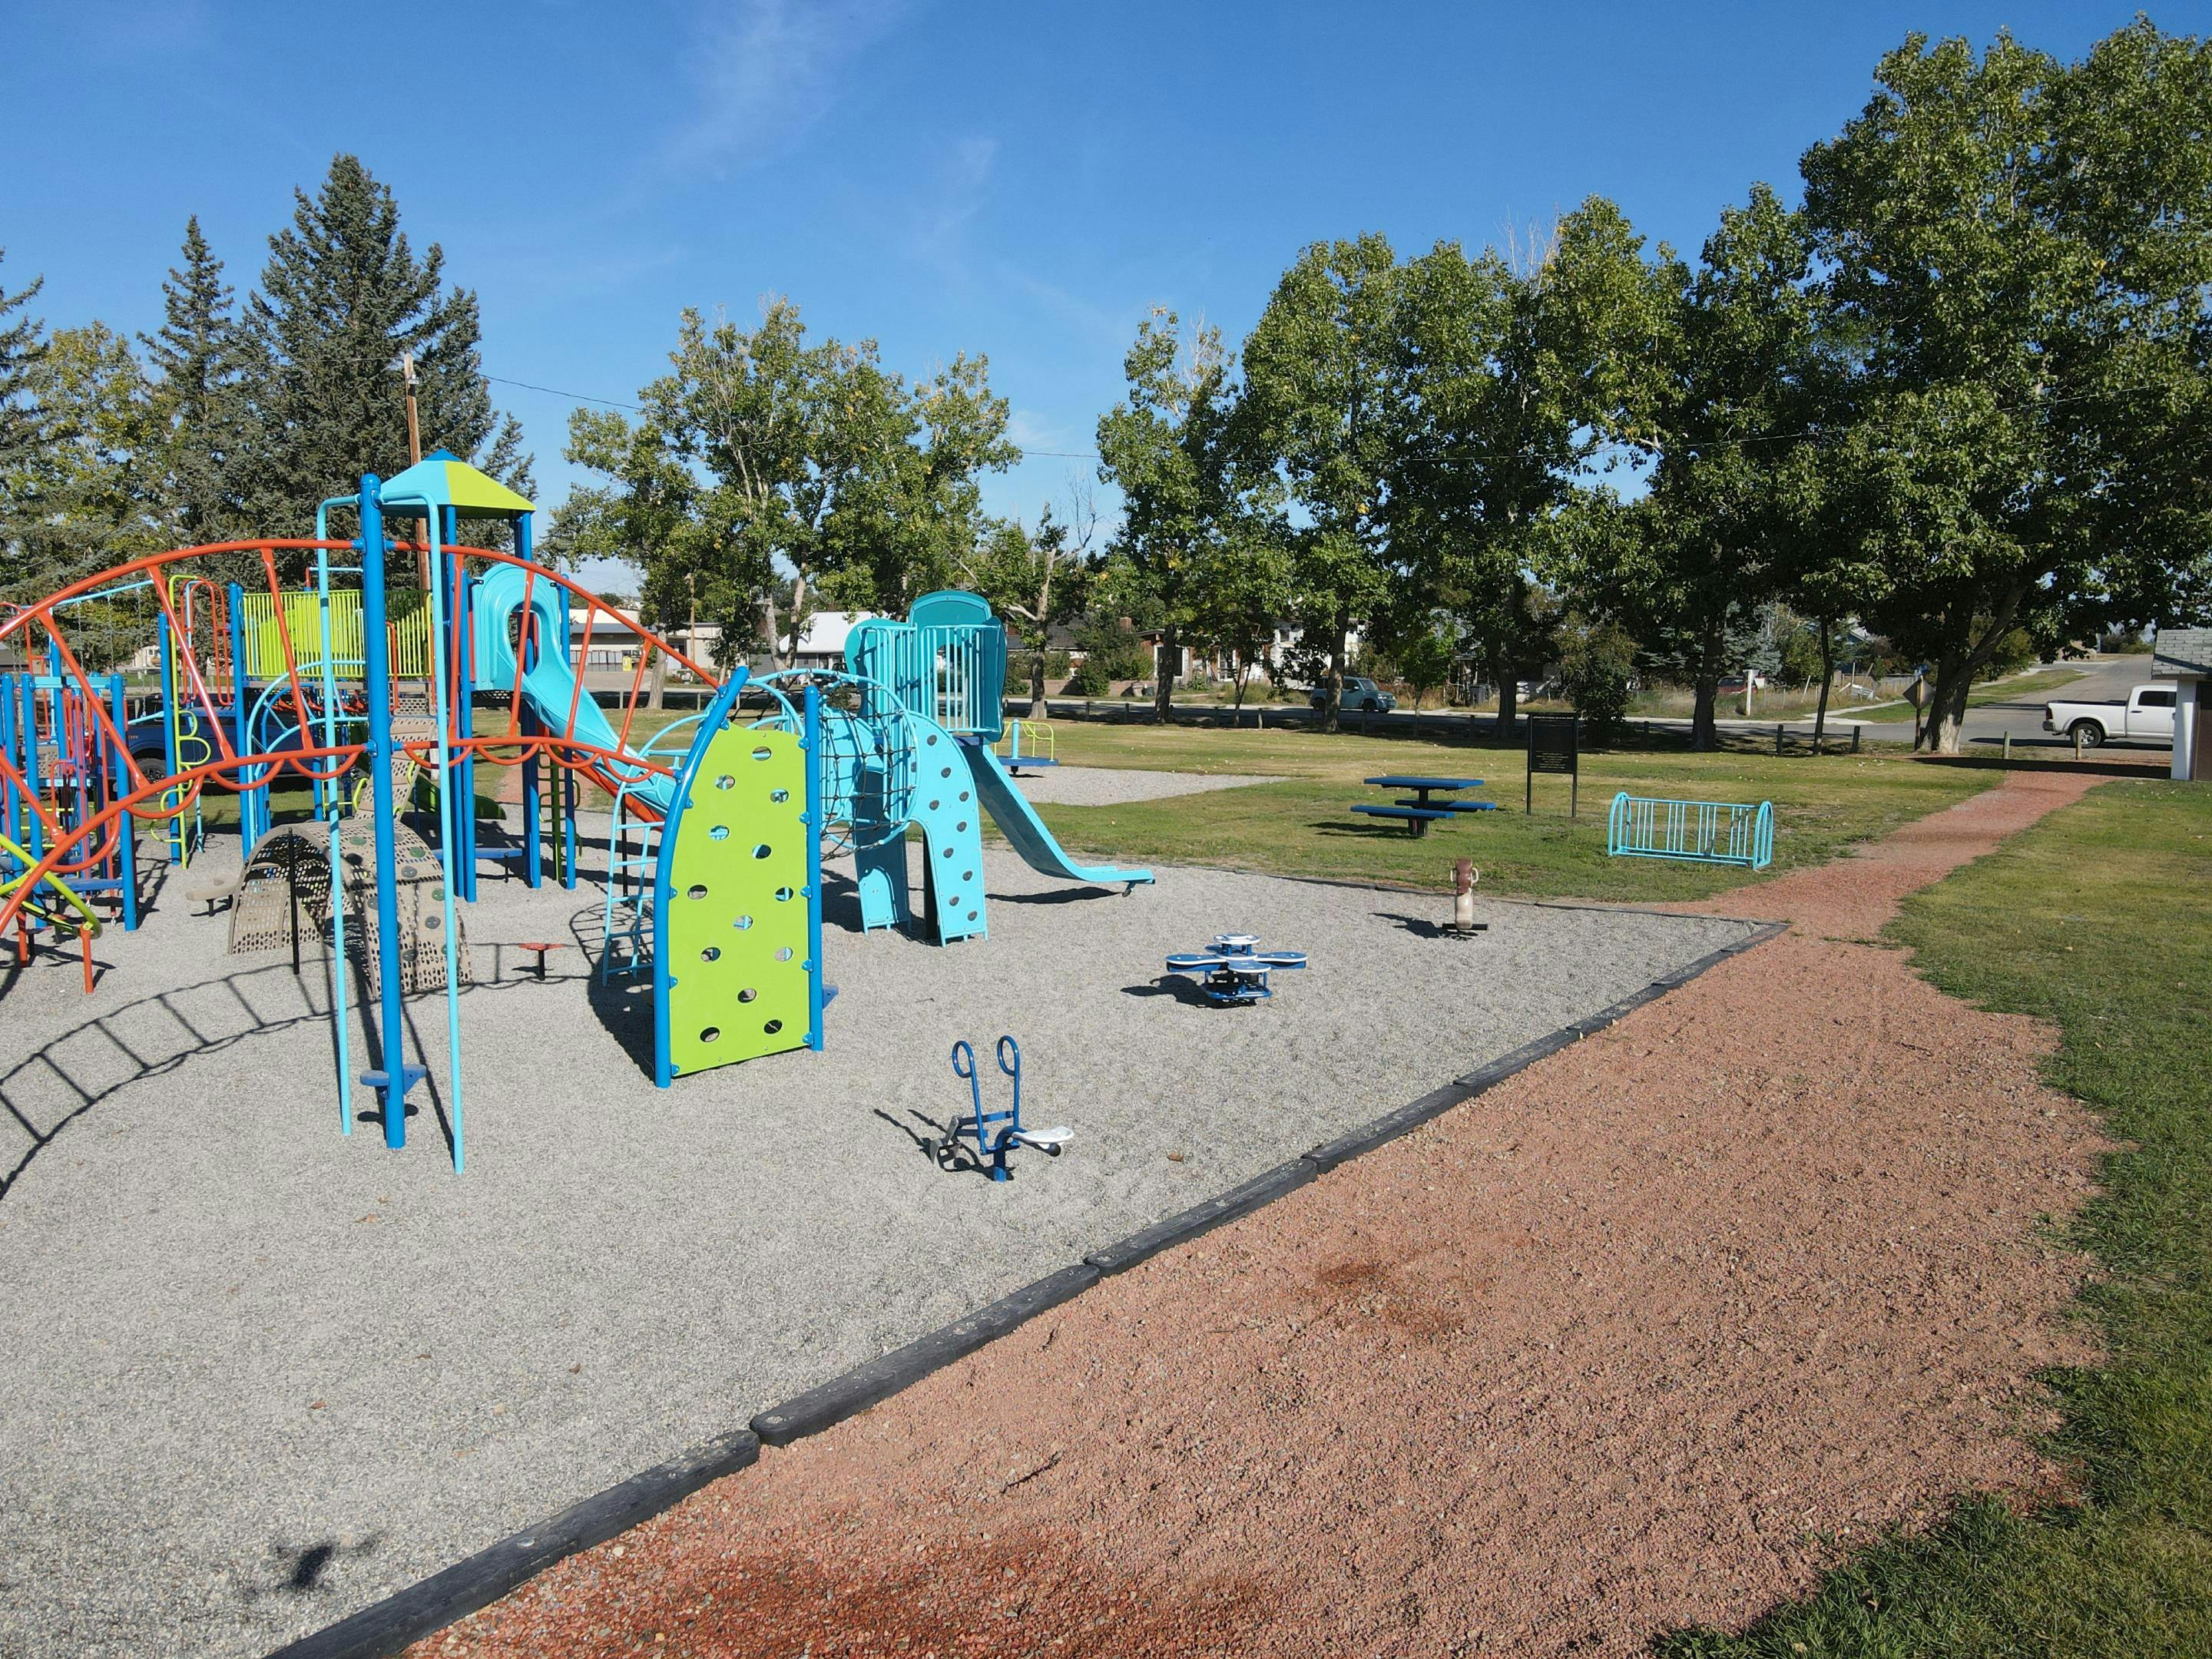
[1013,721,1998,900]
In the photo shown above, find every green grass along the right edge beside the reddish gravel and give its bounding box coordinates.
[1659,783,2212,1659]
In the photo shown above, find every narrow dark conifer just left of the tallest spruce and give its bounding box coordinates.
[139,217,250,542]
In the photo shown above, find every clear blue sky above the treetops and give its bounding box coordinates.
[0,0,2212,579]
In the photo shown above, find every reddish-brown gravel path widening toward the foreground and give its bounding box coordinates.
[420,774,2099,1659]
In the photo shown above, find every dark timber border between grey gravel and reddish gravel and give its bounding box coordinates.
[267,922,1790,1659]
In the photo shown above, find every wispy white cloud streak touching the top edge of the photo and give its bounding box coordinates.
[673,0,907,166]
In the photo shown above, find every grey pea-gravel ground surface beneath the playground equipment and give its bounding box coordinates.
[0,845,1743,1657]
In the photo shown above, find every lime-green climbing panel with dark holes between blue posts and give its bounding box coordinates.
[657,726,810,1075]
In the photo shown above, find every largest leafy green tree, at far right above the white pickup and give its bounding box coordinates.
[1803,20,2212,752]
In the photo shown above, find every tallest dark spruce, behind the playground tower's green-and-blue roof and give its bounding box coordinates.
[241,155,535,535]
